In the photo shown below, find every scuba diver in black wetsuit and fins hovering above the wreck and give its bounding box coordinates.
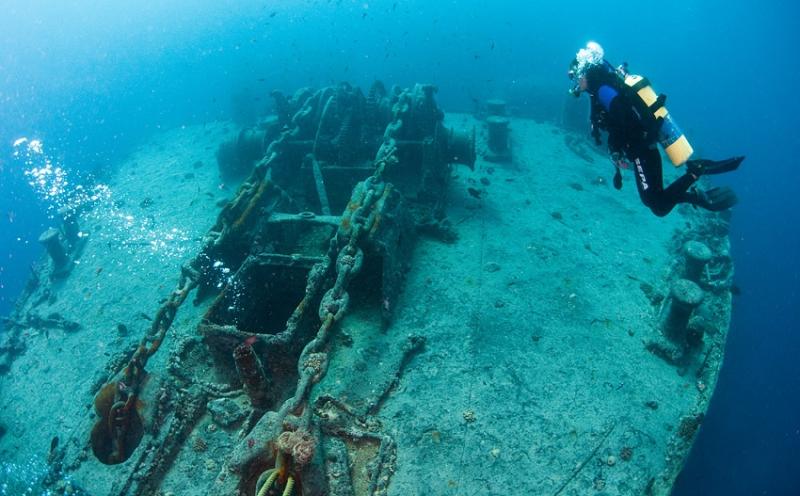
[568,42,744,217]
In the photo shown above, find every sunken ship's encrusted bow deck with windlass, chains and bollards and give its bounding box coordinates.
[0,83,733,495]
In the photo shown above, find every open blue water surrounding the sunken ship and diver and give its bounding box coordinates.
[0,0,800,495]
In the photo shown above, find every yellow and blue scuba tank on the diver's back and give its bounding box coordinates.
[617,64,694,167]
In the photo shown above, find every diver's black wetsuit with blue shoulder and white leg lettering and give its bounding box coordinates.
[586,64,697,217]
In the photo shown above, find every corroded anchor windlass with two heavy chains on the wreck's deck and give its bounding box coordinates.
[50,83,475,495]
